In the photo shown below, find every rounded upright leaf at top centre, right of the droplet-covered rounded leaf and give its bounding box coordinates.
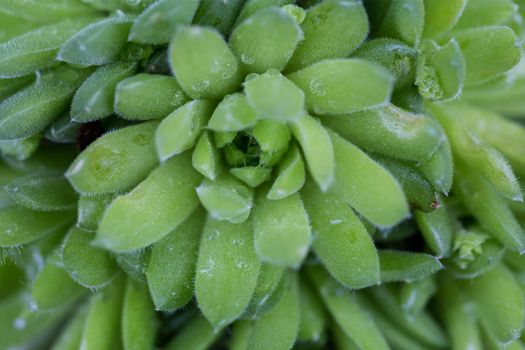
[230,7,303,73]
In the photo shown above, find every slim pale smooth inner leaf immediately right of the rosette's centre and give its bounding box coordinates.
[291,114,336,192]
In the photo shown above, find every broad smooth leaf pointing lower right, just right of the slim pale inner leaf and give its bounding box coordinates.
[330,132,409,227]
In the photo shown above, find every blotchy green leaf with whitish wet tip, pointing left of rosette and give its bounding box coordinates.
[66,122,158,194]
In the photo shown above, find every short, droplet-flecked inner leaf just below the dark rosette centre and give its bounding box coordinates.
[197,173,253,223]
